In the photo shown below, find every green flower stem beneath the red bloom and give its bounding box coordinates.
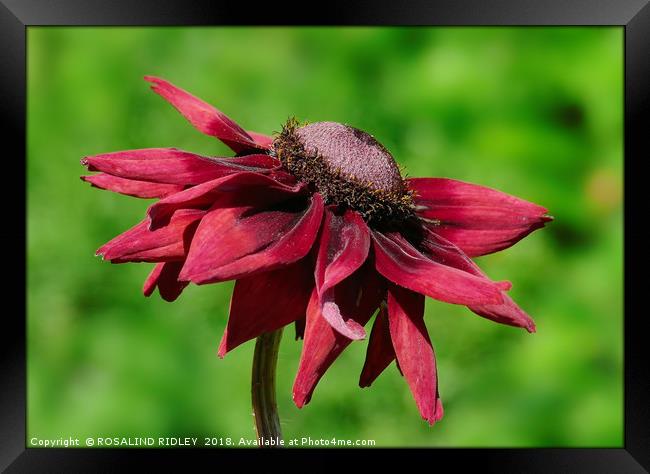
[251,328,282,446]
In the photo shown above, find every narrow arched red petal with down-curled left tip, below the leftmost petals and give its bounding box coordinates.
[147,172,304,229]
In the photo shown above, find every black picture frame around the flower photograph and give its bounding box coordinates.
[0,0,650,473]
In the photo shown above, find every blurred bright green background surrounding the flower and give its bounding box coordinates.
[27,27,623,447]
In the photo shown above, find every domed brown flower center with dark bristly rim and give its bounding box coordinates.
[274,119,413,223]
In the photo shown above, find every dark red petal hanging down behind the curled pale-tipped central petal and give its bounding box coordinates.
[293,261,386,408]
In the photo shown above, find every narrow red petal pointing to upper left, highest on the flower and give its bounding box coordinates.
[144,76,263,153]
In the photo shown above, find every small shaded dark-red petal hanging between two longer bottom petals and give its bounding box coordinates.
[359,305,395,387]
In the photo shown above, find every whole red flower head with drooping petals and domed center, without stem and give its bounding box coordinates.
[82,77,550,424]
